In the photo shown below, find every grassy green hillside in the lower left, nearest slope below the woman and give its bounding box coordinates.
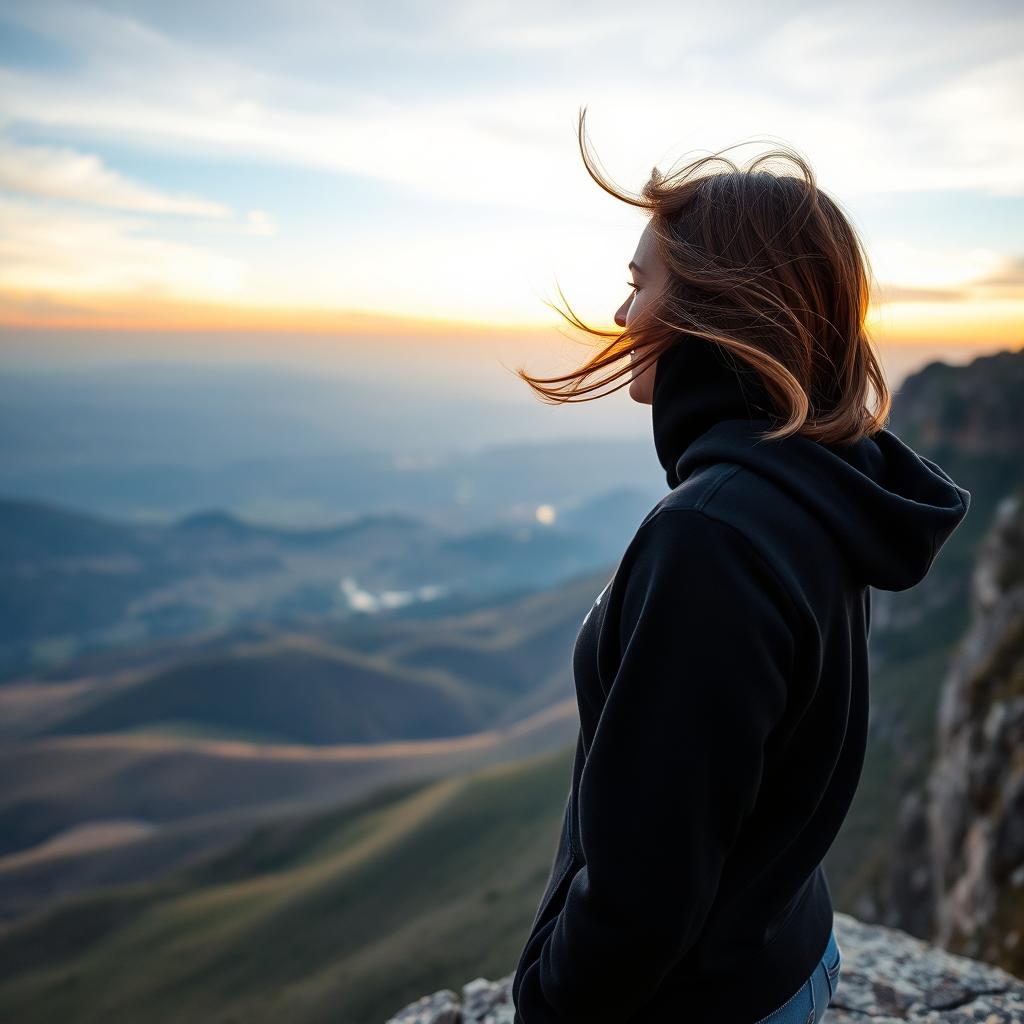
[0,746,572,1024]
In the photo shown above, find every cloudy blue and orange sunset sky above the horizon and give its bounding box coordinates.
[0,0,1024,364]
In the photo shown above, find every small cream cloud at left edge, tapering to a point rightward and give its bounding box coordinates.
[0,139,231,218]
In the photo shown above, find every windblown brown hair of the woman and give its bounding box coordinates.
[516,108,892,443]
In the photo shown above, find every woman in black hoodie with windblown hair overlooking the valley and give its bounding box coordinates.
[512,111,971,1024]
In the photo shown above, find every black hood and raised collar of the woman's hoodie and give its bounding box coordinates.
[651,336,971,591]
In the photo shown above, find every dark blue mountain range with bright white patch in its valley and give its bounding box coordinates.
[0,490,648,682]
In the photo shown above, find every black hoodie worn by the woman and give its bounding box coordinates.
[512,337,971,1024]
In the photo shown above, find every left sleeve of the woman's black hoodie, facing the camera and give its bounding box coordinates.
[515,509,797,1024]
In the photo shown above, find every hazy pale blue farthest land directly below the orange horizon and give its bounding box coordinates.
[0,360,665,534]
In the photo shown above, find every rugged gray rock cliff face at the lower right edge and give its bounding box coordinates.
[884,489,1024,974]
